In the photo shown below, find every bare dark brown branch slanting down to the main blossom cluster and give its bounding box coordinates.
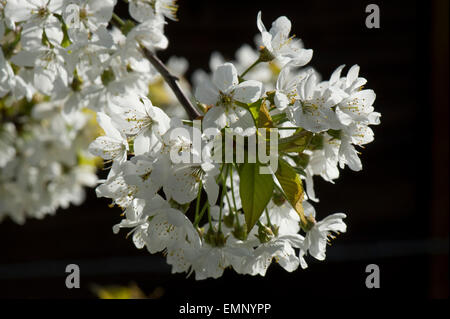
[141,46,201,120]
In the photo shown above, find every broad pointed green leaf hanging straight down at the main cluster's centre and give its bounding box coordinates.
[239,163,274,233]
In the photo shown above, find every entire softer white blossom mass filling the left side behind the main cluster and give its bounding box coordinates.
[0,0,183,223]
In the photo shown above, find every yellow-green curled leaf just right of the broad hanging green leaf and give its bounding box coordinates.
[275,159,305,221]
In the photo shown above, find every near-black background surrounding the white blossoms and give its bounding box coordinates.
[0,0,449,302]
